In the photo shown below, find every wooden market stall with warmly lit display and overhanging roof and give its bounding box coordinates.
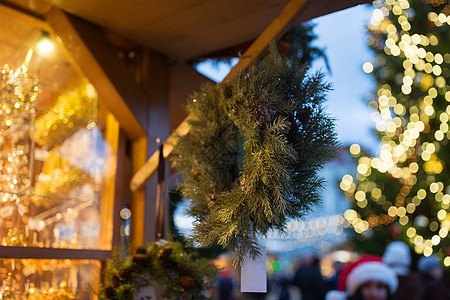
[0,0,368,299]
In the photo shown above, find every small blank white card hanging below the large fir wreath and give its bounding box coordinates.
[241,246,267,293]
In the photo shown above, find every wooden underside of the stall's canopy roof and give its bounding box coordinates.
[4,0,369,59]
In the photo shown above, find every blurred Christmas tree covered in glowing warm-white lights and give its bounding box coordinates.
[340,0,450,266]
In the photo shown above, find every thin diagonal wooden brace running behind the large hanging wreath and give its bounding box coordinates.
[130,0,307,191]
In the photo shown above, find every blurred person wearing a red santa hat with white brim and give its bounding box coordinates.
[325,255,398,300]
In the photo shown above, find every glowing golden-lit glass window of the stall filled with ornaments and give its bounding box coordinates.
[0,7,119,299]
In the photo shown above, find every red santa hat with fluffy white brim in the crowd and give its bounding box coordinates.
[327,255,398,299]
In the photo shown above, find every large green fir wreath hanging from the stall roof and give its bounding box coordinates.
[172,51,338,264]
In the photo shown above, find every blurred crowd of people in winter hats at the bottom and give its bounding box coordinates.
[216,241,450,300]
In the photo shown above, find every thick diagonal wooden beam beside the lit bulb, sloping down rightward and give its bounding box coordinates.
[46,8,147,140]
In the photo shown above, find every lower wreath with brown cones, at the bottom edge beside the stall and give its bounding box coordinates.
[96,240,217,300]
